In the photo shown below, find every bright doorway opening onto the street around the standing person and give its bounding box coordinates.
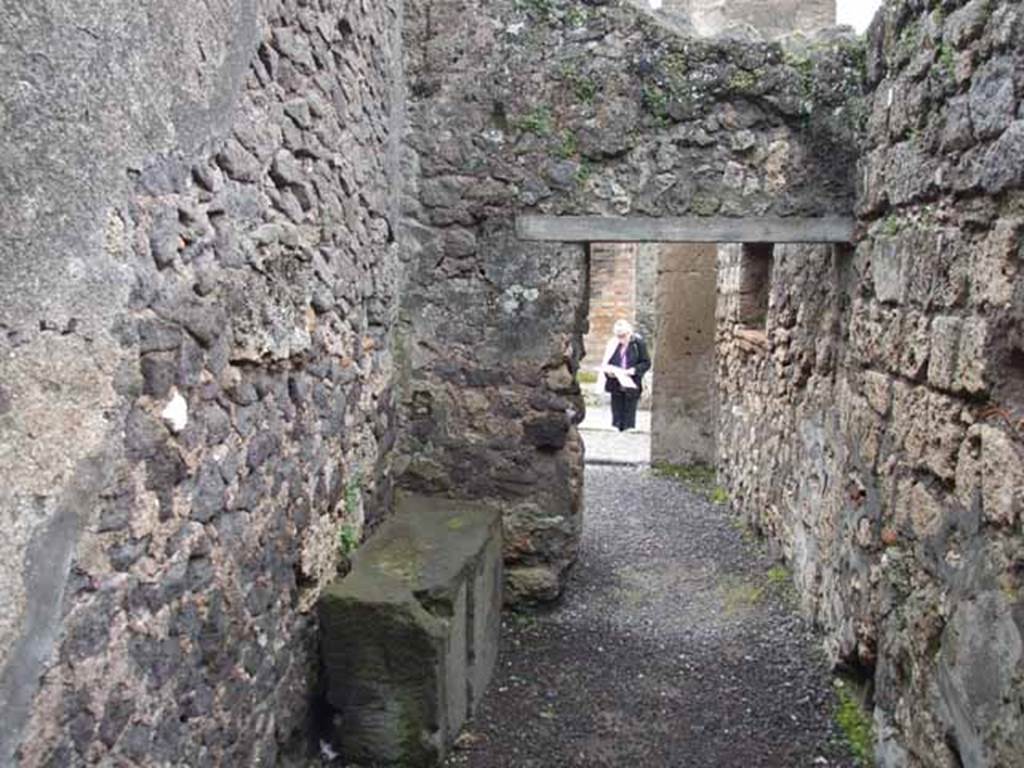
[580,243,718,466]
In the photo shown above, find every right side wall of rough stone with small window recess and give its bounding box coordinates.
[719,0,1024,766]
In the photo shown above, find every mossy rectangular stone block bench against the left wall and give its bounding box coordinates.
[318,496,503,768]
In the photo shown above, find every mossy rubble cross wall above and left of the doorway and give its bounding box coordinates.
[398,0,862,597]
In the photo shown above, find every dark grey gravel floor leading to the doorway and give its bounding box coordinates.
[446,466,856,768]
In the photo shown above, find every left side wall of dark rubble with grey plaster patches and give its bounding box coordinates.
[0,0,400,768]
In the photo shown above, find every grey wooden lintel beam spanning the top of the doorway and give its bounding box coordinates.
[516,215,854,243]
